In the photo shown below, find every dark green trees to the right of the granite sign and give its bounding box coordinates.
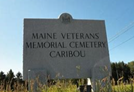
[111,61,134,84]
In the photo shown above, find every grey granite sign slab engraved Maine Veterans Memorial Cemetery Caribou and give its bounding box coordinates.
[23,13,111,79]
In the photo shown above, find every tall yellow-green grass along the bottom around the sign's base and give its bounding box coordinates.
[0,79,134,92]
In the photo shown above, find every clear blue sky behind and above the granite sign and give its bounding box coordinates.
[0,0,134,73]
